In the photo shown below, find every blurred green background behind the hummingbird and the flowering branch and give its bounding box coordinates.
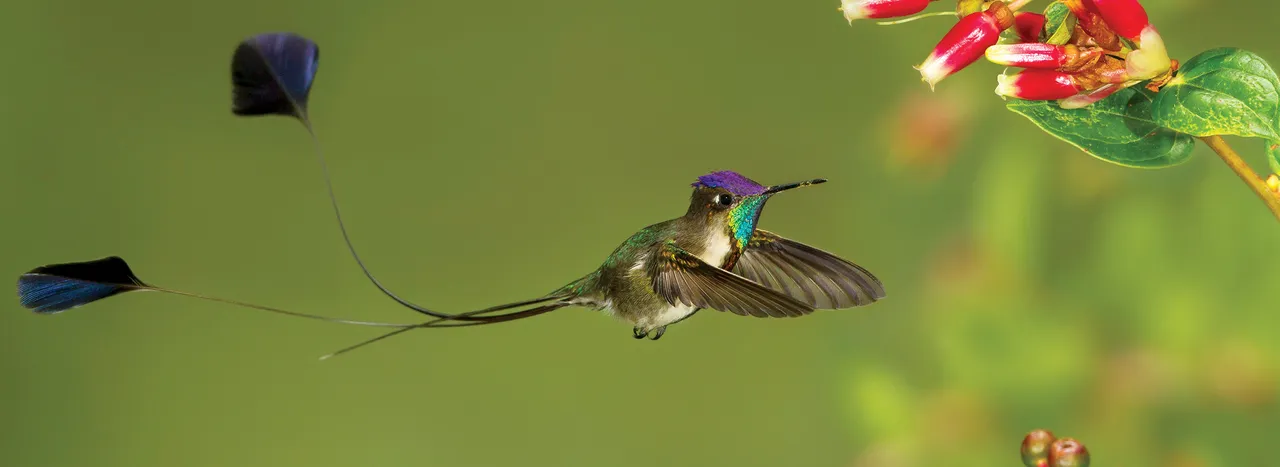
[0,0,1280,467]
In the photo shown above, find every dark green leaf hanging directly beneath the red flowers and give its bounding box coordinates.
[1006,86,1196,169]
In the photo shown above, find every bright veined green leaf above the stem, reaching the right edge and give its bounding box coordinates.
[1152,49,1280,139]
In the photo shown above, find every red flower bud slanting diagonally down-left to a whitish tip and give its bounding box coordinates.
[915,1,1014,88]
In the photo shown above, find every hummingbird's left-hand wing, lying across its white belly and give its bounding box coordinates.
[649,241,813,317]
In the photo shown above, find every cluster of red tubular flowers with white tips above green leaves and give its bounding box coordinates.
[840,0,1178,109]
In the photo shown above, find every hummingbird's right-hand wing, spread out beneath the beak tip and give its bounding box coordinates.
[733,229,884,310]
